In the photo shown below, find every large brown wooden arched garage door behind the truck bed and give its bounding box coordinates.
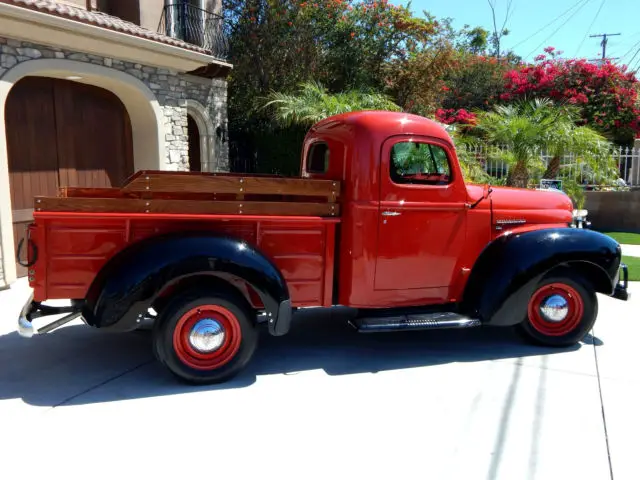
[5,77,133,276]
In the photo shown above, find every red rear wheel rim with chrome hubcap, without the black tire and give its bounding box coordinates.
[173,305,242,370]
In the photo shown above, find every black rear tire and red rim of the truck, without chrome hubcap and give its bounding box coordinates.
[153,291,259,384]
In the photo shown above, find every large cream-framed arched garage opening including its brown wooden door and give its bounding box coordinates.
[0,59,165,282]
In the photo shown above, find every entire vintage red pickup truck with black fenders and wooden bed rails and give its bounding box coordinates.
[18,112,628,383]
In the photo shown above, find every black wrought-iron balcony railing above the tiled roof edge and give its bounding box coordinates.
[158,3,229,60]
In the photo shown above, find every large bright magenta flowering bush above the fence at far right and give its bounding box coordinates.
[500,47,640,143]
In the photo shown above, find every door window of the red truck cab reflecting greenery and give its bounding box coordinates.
[390,141,451,185]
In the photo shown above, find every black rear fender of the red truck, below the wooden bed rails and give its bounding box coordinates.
[83,232,291,335]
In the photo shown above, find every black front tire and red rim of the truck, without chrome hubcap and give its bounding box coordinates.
[516,270,598,347]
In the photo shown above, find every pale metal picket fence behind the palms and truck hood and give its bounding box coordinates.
[457,144,640,187]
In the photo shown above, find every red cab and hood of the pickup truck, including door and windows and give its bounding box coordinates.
[301,112,573,308]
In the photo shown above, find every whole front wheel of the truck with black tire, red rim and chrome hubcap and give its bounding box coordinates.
[519,270,598,347]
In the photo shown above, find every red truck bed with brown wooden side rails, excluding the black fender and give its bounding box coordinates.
[28,171,340,307]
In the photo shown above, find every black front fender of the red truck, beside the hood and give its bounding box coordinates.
[463,228,621,325]
